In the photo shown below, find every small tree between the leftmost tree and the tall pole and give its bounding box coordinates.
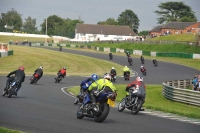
[23,16,37,33]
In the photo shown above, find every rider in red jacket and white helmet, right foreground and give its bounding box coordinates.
[125,76,146,110]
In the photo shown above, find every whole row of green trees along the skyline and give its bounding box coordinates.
[0,1,197,38]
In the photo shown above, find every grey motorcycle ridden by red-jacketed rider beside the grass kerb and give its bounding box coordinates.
[118,87,145,115]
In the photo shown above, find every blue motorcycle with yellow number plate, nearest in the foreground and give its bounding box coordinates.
[76,92,116,123]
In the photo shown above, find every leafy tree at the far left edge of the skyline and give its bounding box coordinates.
[0,8,22,31]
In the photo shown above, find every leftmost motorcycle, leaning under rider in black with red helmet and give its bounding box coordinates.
[2,79,20,98]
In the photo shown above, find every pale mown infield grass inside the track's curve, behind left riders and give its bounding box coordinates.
[0,45,123,76]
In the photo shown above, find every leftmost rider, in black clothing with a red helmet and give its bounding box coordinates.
[4,66,25,96]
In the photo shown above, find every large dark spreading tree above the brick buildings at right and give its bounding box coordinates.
[155,1,197,24]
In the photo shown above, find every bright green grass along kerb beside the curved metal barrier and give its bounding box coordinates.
[67,84,200,119]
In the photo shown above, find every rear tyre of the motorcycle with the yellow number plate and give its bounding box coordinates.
[94,103,110,123]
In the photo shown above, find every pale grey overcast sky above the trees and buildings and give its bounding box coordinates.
[0,0,200,31]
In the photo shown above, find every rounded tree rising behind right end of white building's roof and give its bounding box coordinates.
[117,10,140,33]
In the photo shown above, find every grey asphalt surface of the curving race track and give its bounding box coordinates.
[0,48,200,133]
